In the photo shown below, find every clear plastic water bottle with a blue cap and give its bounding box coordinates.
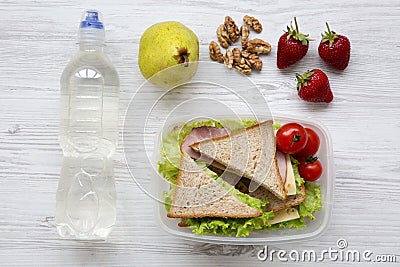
[56,11,119,239]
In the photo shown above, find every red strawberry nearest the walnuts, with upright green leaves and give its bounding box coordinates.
[276,17,311,69]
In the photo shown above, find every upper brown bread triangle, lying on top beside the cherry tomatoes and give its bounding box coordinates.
[191,120,286,200]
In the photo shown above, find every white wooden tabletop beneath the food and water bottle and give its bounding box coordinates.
[0,0,400,266]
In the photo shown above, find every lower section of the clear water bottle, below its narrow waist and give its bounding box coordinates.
[56,156,116,239]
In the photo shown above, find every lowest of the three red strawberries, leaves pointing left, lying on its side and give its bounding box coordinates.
[296,69,333,103]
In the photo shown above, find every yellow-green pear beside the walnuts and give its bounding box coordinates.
[139,21,199,88]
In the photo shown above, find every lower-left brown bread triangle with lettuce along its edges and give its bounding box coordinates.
[167,153,262,218]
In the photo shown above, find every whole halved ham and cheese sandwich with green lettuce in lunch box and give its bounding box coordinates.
[158,120,321,237]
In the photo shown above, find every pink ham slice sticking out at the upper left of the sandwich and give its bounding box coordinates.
[181,126,230,159]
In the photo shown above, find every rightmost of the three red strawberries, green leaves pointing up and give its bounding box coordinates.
[318,22,350,70]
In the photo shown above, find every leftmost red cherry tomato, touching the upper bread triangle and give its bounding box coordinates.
[276,123,308,154]
